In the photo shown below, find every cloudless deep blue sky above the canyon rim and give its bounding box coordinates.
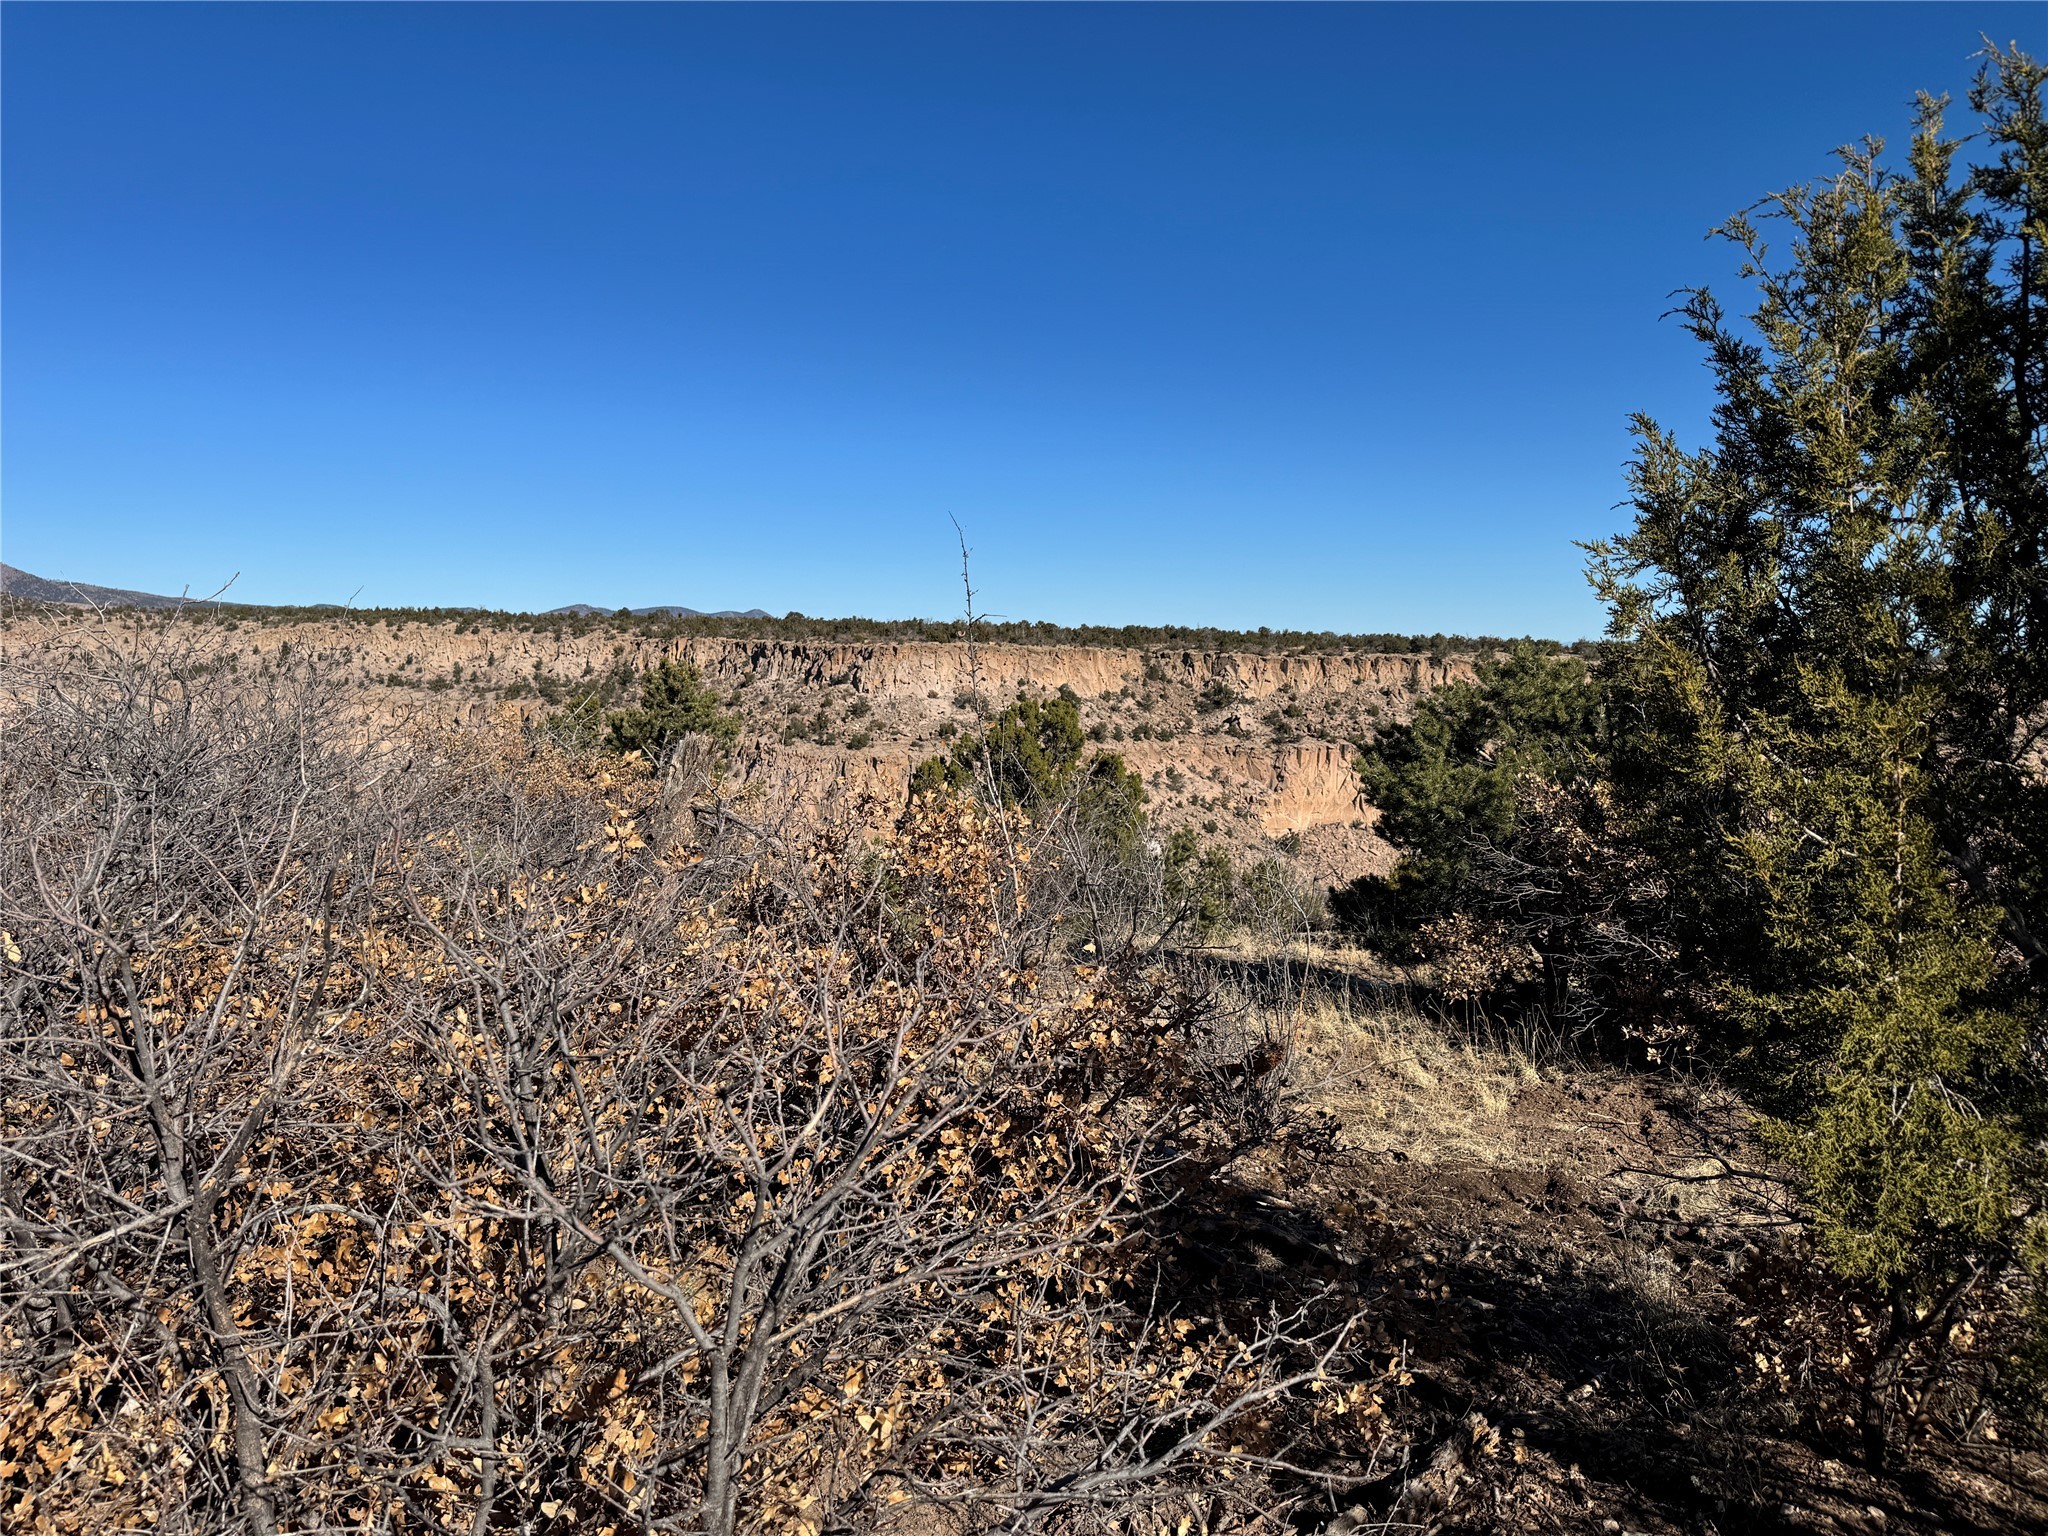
[0,4,2048,637]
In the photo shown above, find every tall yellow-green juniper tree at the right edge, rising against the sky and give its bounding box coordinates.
[1593,49,2048,1462]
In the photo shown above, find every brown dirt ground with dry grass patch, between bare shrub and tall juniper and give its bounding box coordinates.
[1187,974,2048,1536]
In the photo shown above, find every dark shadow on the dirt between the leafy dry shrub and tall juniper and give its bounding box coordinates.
[1138,1028,2048,1536]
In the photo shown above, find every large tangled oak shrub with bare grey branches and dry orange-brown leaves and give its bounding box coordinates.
[0,625,1380,1534]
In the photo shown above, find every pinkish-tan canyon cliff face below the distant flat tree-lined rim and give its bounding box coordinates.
[0,616,1470,883]
